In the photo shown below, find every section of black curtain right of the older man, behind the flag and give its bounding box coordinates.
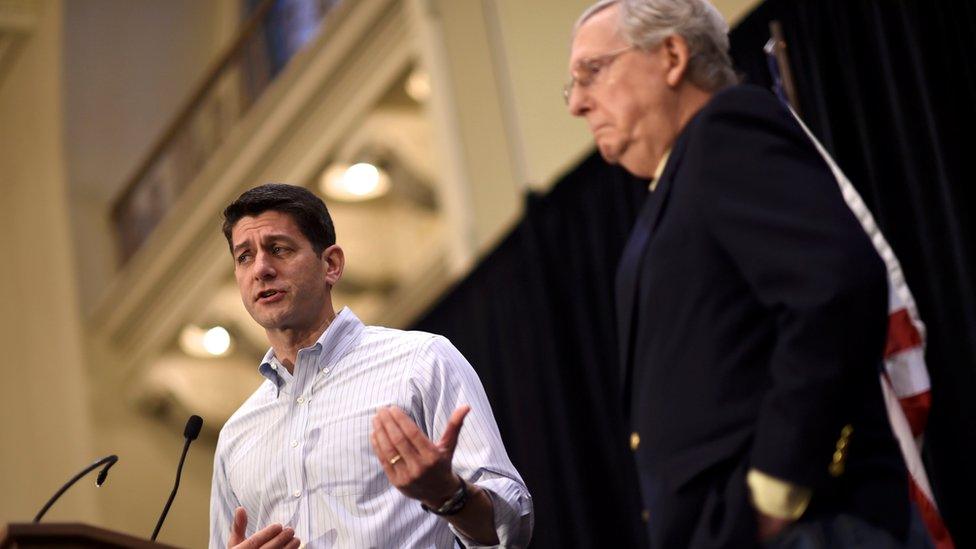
[732,0,976,547]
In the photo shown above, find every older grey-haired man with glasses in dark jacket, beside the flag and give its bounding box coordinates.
[565,0,910,548]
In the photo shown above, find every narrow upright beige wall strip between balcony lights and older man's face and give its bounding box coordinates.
[417,0,524,252]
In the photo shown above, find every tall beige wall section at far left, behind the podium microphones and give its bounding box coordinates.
[0,0,97,522]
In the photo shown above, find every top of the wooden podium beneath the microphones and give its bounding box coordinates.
[0,522,177,549]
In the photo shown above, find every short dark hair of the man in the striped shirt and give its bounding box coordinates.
[223,183,335,254]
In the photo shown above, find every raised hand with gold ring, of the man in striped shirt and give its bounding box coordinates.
[370,406,471,509]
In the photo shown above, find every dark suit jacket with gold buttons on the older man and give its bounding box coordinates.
[616,86,908,548]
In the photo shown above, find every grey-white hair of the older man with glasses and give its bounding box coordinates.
[573,0,739,91]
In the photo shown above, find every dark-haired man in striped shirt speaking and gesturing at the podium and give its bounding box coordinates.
[210,184,532,549]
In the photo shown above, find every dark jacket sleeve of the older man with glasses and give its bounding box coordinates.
[687,88,887,488]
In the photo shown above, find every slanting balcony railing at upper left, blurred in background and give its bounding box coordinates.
[111,0,341,264]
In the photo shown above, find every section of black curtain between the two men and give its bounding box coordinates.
[415,155,647,547]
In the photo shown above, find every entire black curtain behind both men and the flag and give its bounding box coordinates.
[415,0,976,547]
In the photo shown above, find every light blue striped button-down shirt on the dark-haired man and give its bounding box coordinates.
[210,308,533,549]
